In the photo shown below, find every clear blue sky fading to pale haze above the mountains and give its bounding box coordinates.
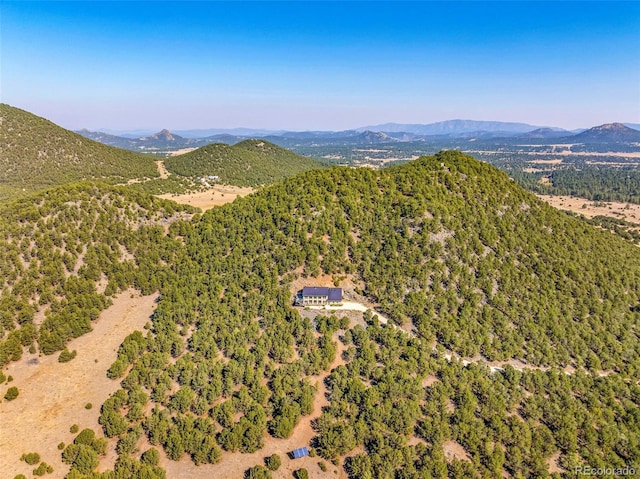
[0,0,640,130]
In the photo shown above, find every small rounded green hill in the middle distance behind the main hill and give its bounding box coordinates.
[165,140,324,186]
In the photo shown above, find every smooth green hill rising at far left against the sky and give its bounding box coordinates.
[0,104,158,199]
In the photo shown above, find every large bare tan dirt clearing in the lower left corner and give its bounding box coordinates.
[0,290,157,479]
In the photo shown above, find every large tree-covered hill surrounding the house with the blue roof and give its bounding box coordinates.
[82,152,640,478]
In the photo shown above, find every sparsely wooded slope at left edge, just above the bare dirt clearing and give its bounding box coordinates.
[0,184,192,366]
